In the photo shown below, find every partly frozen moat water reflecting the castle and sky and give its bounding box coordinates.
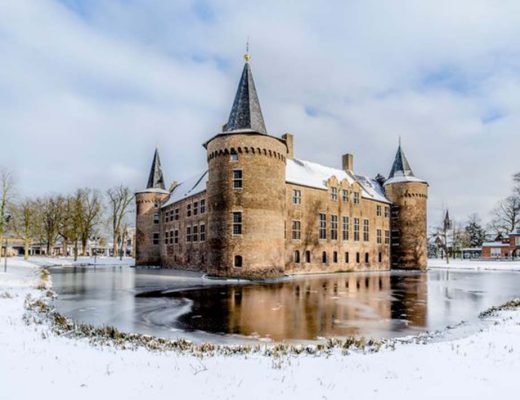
[50,266,520,342]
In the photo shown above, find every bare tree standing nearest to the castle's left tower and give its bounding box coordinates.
[107,185,134,257]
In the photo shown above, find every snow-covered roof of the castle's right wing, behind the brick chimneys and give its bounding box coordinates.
[285,159,390,203]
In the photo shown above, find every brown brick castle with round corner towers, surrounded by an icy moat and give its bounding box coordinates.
[135,55,428,278]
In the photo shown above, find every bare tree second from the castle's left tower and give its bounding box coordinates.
[76,188,103,255]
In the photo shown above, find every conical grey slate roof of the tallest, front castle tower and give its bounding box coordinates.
[223,61,267,135]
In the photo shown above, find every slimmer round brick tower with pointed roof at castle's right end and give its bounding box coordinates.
[384,143,428,270]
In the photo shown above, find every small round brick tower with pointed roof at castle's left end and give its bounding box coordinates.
[135,149,169,265]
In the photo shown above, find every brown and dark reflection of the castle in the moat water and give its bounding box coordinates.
[171,273,428,340]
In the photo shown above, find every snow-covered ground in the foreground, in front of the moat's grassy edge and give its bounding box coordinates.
[0,260,520,400]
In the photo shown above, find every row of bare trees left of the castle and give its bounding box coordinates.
[0,170,134,258]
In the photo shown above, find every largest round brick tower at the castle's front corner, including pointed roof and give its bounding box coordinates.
[205,57,287,277]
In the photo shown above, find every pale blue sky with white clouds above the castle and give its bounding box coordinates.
[0,0,520,225]
